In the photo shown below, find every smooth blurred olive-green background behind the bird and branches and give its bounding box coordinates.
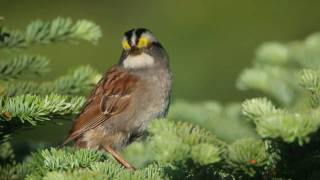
[0,0,320,102]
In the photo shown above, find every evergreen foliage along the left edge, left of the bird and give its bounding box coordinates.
[0,18,101,179]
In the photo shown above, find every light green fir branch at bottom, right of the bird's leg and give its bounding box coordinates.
[125,120,279,178]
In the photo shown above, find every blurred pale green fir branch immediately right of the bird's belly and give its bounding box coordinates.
[168,100,256,142]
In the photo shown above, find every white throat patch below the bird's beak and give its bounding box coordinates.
[123,53,154,69]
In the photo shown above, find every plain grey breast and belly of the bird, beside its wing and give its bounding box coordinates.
[130,68,172,132]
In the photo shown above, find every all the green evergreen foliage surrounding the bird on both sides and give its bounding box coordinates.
[0,18,320,180]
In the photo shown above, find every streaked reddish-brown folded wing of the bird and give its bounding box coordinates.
[63,66,138,145]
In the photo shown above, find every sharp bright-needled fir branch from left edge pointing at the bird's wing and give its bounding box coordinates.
[0,94,84,134]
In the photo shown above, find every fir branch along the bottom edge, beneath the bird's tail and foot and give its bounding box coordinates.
[25,148,164,180]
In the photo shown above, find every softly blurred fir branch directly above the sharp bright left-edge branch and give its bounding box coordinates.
[0,66,100,96]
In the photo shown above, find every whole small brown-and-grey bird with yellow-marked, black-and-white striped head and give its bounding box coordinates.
[63,28,172,169]
